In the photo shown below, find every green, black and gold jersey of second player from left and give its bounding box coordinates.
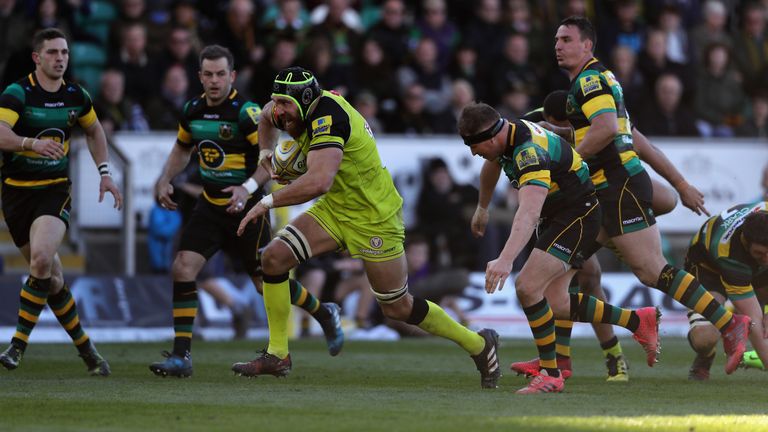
[176,89,261,206]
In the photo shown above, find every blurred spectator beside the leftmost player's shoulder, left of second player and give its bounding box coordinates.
[93,69,149,138]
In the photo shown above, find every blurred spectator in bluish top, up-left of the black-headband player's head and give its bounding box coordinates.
[397,39,451,114]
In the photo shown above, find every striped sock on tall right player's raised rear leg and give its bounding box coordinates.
[656,264,733,332]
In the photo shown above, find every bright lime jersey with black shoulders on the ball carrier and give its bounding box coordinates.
[271,91,403,224]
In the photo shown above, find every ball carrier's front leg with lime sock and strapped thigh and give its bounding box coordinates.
[232,213,339,376]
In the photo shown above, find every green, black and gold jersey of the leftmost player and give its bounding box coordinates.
[0,72,97,188]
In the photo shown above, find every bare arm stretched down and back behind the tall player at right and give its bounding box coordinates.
[632,127,709,216]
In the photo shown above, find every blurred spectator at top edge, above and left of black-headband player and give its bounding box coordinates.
[413,0,460,71]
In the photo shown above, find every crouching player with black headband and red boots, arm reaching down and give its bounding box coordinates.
[459,104,659,394]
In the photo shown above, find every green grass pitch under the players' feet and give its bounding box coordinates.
[0,338,768,432]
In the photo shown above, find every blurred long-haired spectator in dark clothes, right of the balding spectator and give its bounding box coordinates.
[695,43,745,137]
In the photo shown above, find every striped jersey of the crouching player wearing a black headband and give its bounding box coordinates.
[498,120,595,217]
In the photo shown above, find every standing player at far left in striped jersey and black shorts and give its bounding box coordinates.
[0,28,122,376]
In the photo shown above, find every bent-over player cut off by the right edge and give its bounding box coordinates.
[685,201,768,380]
